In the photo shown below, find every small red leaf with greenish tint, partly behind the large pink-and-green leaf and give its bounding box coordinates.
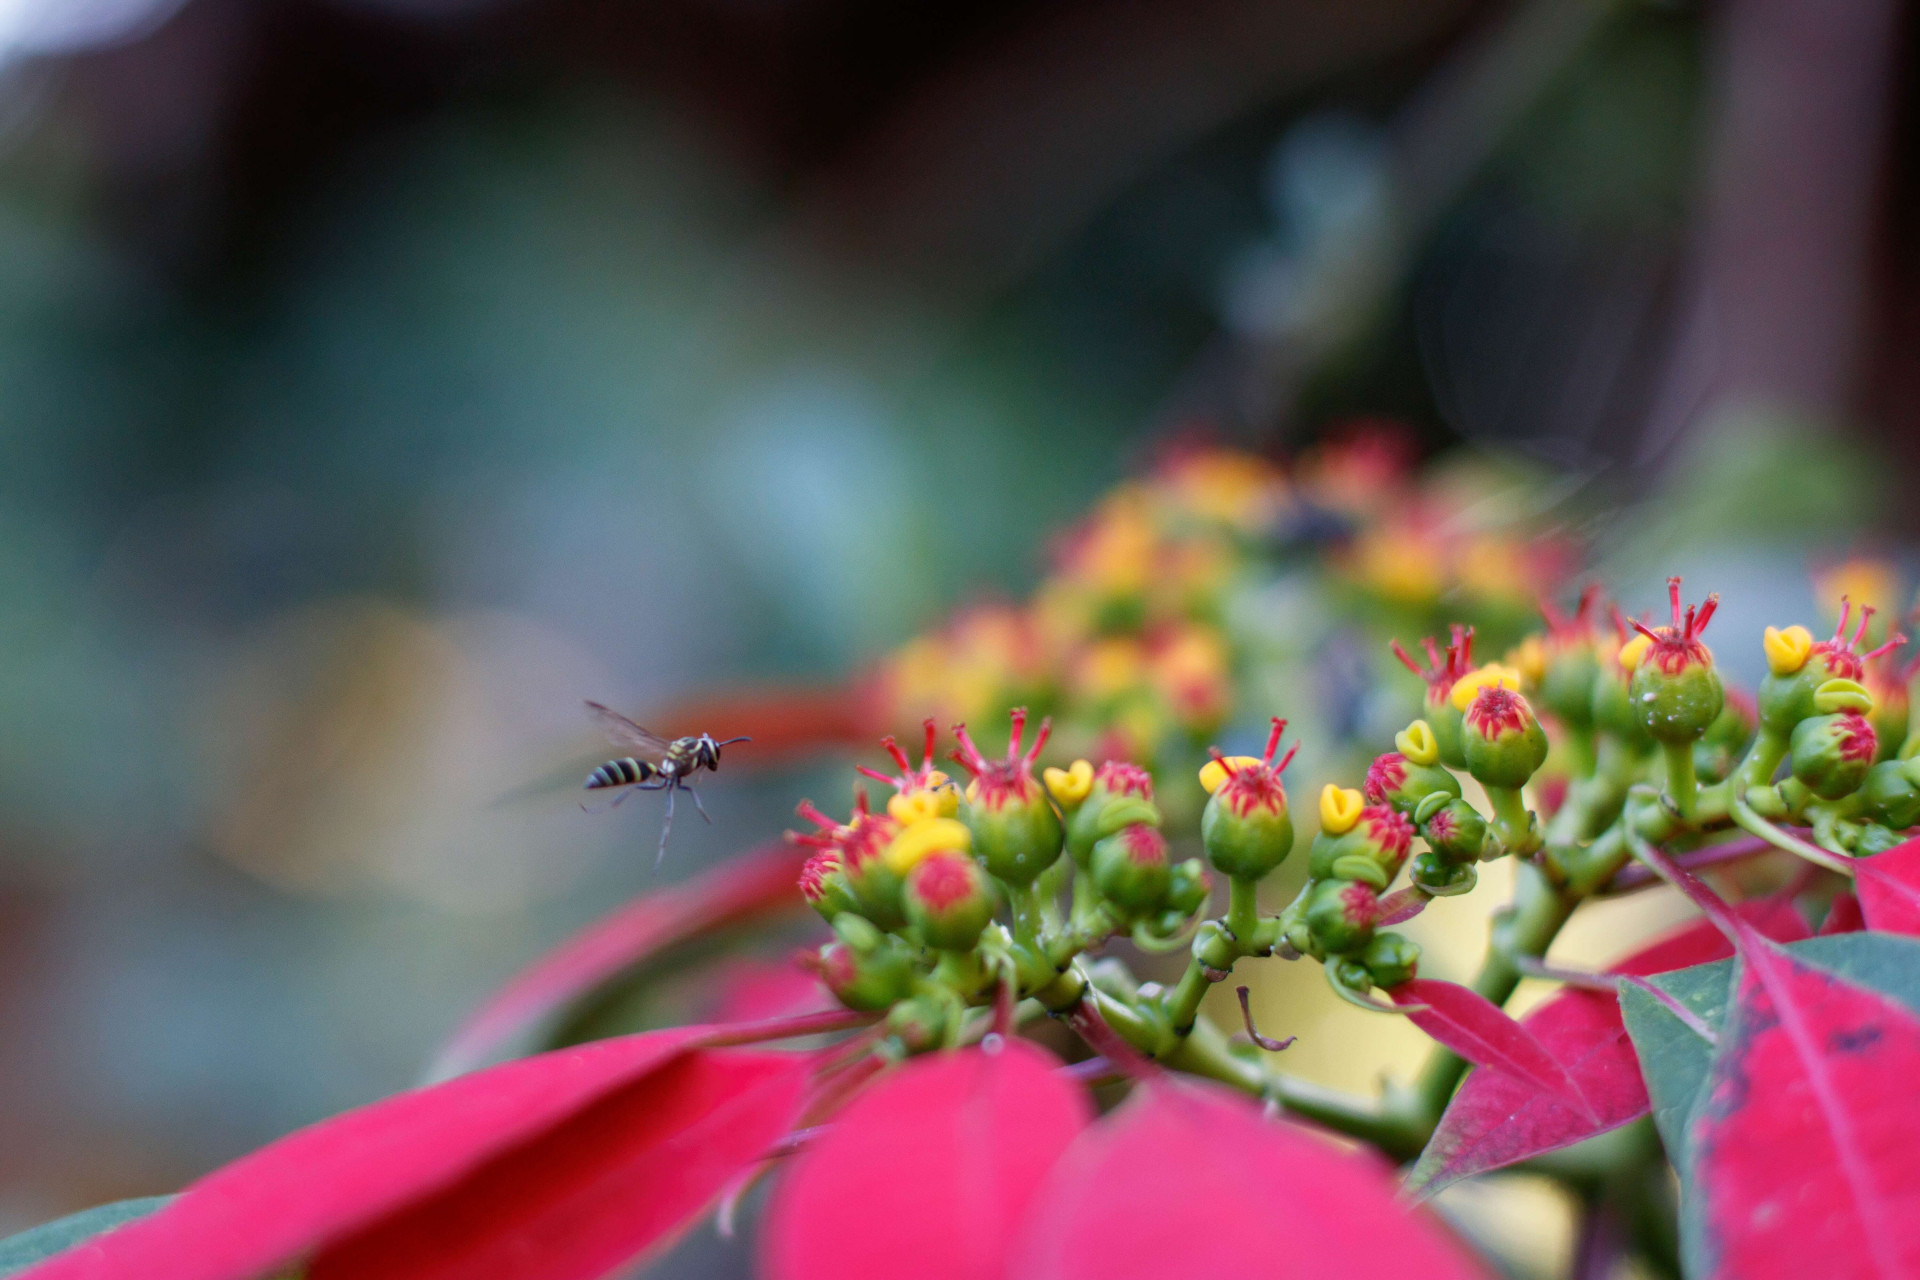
[1407,898,1807,1196]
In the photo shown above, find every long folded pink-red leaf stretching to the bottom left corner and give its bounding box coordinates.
[25,1027,812,1280]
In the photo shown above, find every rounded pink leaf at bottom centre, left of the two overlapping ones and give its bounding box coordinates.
[762,1040,1091,1280]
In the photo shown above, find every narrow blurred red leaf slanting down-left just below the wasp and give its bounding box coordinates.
[428,842,810,1080]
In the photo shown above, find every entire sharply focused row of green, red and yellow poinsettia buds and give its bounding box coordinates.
[793,578,1920,1055]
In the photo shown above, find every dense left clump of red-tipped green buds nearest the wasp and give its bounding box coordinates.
[789,708,1212,1050]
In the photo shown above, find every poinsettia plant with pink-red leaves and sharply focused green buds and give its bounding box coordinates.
[0,445,1920,1280]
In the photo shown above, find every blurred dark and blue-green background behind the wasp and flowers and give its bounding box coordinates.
[0,0,1920,1274]
